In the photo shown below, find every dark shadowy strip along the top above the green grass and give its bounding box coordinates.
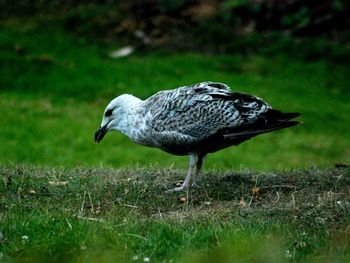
[0,0,350,60]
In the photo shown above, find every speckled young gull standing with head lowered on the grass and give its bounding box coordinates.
[95,81,300,192]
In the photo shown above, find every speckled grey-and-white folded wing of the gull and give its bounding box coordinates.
[145,82,271,144]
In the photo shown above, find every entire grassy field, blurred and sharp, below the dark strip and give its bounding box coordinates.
[0,20,350,262]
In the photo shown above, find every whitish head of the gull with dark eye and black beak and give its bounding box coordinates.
[95,94,141,143]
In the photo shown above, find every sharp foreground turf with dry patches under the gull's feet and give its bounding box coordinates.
[0,166,350,262]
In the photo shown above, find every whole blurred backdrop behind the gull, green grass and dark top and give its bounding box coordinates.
[0,0,350,170]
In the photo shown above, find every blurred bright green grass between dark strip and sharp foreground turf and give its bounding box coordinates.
[0,20,350,169]
